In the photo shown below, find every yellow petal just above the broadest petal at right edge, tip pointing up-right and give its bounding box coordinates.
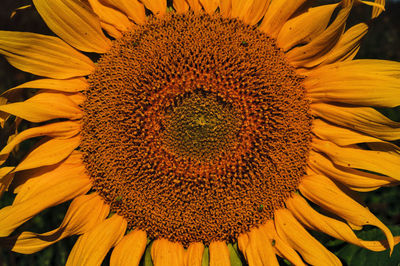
[322,23,368,65]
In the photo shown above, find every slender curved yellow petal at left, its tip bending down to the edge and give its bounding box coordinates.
[0,121,81,164]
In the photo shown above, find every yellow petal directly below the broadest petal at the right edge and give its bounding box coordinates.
[312,103,400,141]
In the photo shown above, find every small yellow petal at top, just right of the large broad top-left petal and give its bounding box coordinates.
[88,0,133,31]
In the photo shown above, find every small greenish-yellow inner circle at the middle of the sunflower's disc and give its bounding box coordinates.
[160,94,240,161]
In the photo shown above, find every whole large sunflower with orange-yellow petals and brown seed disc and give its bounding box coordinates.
[0,0,400,266]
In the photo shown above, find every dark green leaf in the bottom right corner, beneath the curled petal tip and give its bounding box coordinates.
[335,226,400,266]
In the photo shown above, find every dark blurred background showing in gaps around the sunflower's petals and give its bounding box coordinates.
[0,0,400,266]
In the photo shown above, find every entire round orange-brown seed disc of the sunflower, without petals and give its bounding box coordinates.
[80,13,312,245]
